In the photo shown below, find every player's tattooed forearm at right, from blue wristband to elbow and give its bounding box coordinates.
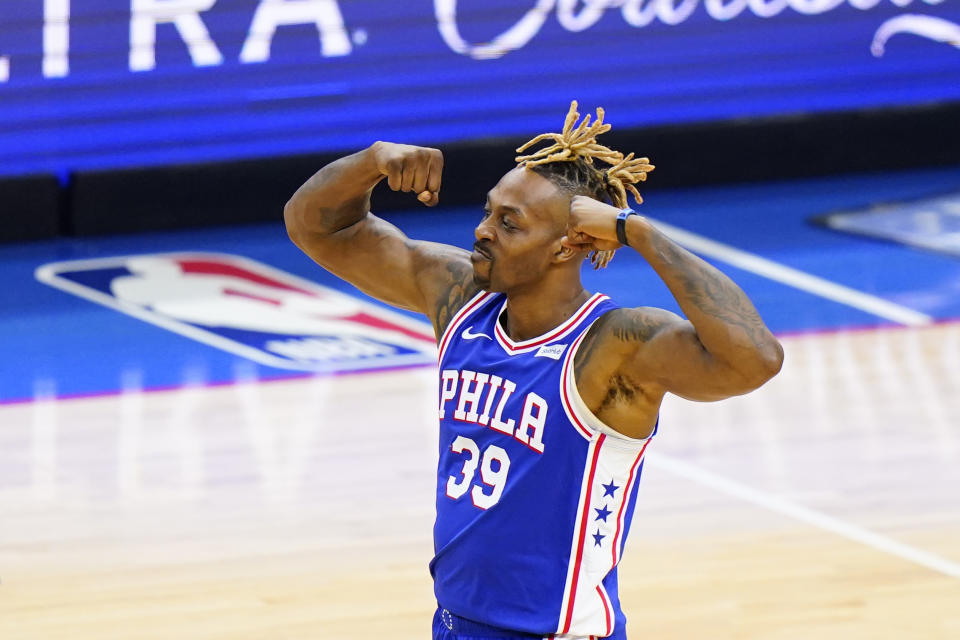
[627,212,783,376]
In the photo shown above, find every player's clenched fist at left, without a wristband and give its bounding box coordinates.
[370,142,443,207]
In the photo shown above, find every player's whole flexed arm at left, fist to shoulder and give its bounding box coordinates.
[284,142,478,338]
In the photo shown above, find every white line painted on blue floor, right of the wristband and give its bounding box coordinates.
[648,218,933,327]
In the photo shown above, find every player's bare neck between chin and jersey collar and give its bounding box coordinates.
[506,278,590,342]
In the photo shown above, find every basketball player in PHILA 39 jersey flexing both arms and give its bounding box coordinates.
[284,102,783,640]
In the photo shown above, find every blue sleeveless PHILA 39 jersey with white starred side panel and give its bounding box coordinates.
[430,292,649,638]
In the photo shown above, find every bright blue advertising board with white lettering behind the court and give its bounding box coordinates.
[0,0,960,175]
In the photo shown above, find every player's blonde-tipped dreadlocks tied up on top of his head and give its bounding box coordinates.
[516,100,654,268]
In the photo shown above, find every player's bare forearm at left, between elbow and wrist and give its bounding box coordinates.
[283,147,384,236]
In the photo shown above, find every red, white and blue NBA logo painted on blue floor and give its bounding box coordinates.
[36,253,436,372]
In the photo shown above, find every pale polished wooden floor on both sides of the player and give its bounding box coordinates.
[0,323,960,640]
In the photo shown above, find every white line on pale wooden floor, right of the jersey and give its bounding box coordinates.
[647,452,960,580]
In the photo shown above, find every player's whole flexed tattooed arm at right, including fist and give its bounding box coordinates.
[568,196,783,400]
